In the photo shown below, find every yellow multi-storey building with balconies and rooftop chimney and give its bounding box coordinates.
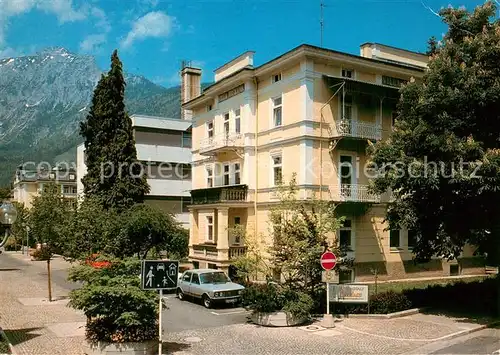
[181,43,480,281]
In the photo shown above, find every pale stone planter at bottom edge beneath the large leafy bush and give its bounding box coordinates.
[83,340,158,355]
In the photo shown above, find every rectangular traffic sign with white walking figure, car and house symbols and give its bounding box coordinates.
[141,260,179,290]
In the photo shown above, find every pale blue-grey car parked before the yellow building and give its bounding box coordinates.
[177,269,245,308]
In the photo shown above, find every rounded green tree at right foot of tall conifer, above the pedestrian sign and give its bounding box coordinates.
[106,204,189,259]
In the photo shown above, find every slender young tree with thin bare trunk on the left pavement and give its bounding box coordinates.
[29,183,70,301]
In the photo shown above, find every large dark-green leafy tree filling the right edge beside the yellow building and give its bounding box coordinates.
[371,1,500,312]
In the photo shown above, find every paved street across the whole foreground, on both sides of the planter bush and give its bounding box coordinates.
[0,253,500,355]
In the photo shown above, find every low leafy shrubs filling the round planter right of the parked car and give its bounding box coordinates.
[242,282,314,318]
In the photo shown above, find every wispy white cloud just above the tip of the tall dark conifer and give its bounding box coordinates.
[122,11,175,48]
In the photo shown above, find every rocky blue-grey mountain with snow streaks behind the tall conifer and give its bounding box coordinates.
[0,47,184,185]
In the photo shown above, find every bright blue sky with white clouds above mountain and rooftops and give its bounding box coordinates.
[0,0,494,87]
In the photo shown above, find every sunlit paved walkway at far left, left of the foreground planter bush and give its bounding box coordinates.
[0,252,85,355]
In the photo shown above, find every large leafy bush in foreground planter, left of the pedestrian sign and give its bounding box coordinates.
[69,259,158,343]
